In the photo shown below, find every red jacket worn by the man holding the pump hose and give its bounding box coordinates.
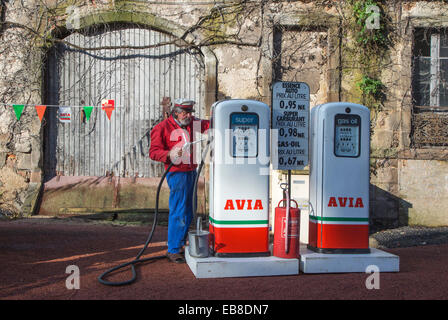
[149,115,210,172]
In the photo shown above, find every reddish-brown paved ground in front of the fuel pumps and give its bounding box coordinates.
[0,219,448,300]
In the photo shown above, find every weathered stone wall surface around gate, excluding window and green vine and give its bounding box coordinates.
[0,0,448,228]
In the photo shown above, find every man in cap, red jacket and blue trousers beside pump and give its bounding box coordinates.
[149,99,209,263]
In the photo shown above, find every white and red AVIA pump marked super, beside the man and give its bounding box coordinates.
[209,100,270,257]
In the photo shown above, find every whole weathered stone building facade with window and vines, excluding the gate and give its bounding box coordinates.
[0,0,448,228]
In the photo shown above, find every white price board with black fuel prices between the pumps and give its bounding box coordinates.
[272,82,310,170]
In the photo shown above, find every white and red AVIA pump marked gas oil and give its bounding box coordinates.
[308,102,370,253]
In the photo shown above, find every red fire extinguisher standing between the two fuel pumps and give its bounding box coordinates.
[272,189,300,259]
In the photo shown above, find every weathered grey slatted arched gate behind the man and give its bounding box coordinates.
[44,25,205,181]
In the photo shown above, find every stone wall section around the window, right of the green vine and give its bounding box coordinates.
[371,1,448,227]
